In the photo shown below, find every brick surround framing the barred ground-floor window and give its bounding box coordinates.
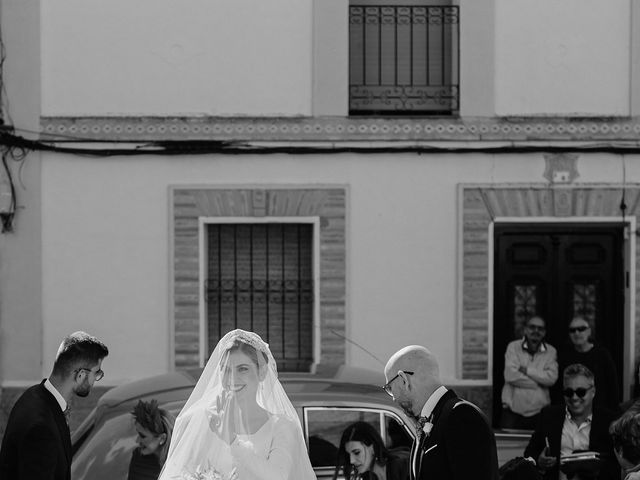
[170,186,347,369]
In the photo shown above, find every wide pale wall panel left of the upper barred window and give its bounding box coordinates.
[41,0,312,115]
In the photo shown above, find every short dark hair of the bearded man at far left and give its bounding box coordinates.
[53,332,109,376]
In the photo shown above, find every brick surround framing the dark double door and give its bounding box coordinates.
[459,184,640,380]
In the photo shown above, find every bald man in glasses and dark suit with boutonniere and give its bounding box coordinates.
[384,345,498,480]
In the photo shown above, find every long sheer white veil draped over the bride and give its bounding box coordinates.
[159,329,315,480]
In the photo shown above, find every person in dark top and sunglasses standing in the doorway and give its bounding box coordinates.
[556,317,620,412]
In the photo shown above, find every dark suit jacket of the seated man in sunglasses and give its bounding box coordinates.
[524,405,620,480]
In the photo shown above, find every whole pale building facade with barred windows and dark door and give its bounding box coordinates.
[0,0,640,428]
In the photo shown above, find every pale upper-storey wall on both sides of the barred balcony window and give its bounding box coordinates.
[42,0,638,116]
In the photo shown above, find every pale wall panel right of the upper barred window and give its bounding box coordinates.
[495,0,631,116]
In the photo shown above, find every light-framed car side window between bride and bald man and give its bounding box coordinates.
[304,407,412,467]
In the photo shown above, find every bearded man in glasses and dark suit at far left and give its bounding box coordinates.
[0,332,109,480]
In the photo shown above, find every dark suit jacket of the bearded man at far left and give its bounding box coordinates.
[0,380,71,480]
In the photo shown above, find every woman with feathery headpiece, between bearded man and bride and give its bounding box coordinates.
[128,400,174,480]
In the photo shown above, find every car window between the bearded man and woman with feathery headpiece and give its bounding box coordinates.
[71,413,136,480]
